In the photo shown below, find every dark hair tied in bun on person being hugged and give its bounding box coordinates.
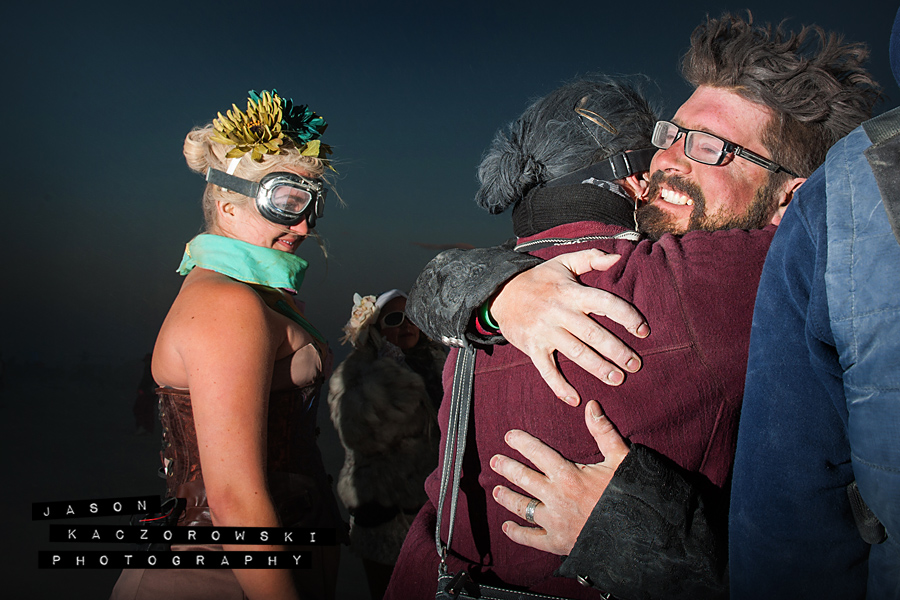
[475,75,657,214]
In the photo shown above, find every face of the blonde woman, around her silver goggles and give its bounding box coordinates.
[218,167,310,253]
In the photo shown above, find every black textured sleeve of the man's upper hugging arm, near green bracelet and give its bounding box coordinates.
[406,246,543,346]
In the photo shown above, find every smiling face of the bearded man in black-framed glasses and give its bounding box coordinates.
[637,86,774,238]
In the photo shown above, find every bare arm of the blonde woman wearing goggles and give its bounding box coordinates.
[178,279,298,600]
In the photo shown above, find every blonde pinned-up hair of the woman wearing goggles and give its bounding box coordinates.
[184,123,325,233]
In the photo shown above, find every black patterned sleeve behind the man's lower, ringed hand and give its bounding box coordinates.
[559,444,728,600]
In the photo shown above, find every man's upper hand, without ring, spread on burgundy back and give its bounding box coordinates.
[491,250,650,406]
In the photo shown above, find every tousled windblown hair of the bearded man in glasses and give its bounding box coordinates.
[682,11,881,177]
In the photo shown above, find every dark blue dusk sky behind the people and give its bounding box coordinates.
[0,0,898,364]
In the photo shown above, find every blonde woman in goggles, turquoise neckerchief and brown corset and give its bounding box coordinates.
[106,90,347,600]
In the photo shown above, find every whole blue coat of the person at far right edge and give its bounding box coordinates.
[729,115,900,598]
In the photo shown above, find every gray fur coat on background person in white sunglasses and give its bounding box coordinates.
[328,340,446,564]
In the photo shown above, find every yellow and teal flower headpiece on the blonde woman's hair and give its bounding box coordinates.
[210,89,331,162]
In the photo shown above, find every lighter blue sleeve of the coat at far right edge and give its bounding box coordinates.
[825,109,900,598]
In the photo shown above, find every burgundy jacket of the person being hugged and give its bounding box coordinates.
[385,222,775,599]
